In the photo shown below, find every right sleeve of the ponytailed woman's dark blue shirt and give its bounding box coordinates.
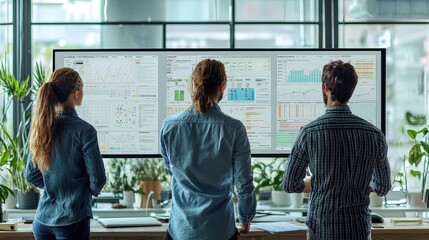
[82,127,106,196]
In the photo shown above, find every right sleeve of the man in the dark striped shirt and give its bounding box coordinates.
[370,138,392,197]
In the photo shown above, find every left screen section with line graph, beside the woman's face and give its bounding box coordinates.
[64,54,159,154]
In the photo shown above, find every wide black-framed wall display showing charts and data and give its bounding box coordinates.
[54,49,385,157]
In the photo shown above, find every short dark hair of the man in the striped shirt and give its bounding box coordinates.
[322,60,358,103]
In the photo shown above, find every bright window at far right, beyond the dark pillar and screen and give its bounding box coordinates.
[338,0,429,194]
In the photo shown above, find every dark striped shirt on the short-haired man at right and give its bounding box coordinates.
[283,105,391,240]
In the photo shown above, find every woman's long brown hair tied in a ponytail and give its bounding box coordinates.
[30,68,82,172]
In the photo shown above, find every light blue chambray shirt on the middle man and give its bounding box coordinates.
[160,104,256,240]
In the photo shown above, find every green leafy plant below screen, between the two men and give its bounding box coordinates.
[252,158,287,193]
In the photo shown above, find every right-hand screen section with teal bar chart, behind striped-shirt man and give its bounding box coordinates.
[275,54,377,152]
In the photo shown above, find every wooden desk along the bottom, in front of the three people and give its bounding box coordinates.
[0,218,429,240]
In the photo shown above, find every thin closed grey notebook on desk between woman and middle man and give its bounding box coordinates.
[98,217,161,228]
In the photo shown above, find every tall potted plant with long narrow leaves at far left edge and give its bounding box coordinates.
[0,63,47,209]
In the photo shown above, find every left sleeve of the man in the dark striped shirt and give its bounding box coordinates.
[282,133,309,193]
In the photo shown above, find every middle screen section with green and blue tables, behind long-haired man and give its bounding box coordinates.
[166,55,272,150]
